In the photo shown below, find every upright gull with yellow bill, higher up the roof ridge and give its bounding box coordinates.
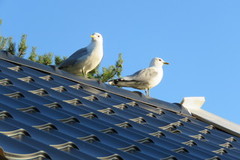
[58,33,103,77]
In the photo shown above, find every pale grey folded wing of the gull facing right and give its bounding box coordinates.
[126,67,158,81]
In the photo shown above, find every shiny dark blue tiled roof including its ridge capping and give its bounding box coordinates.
[0,51,240,160]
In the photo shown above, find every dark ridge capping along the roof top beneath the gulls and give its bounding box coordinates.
[0,50,190,116]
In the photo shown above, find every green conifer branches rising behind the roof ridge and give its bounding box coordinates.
[0,19,123,82]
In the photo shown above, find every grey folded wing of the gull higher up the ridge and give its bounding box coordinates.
[58,47,88,69]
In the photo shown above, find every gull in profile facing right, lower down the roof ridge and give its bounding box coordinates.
[108,57,169,96]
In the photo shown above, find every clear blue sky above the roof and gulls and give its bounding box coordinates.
[0,0,240,124]
